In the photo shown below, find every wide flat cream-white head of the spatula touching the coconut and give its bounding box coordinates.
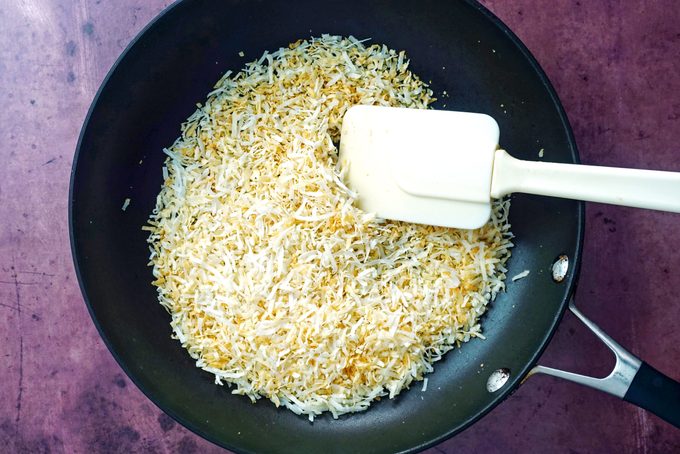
[340,106,500,229]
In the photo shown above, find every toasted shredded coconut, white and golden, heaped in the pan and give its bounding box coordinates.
[143,35,512,420]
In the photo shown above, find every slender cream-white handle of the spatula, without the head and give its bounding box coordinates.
[491,150,680,213]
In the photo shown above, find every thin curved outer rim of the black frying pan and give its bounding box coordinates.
[68,0,585,453]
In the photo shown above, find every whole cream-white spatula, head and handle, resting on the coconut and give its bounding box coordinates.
[339,106,680,229]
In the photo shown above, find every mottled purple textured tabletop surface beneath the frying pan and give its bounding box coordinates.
[0,0,680,453]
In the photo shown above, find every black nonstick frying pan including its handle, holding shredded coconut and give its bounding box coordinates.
[69,0,680,452]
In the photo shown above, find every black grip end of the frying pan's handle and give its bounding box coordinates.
[623,362,680,428]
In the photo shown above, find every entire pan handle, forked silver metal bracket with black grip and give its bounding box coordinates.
[527,301,680,428]
